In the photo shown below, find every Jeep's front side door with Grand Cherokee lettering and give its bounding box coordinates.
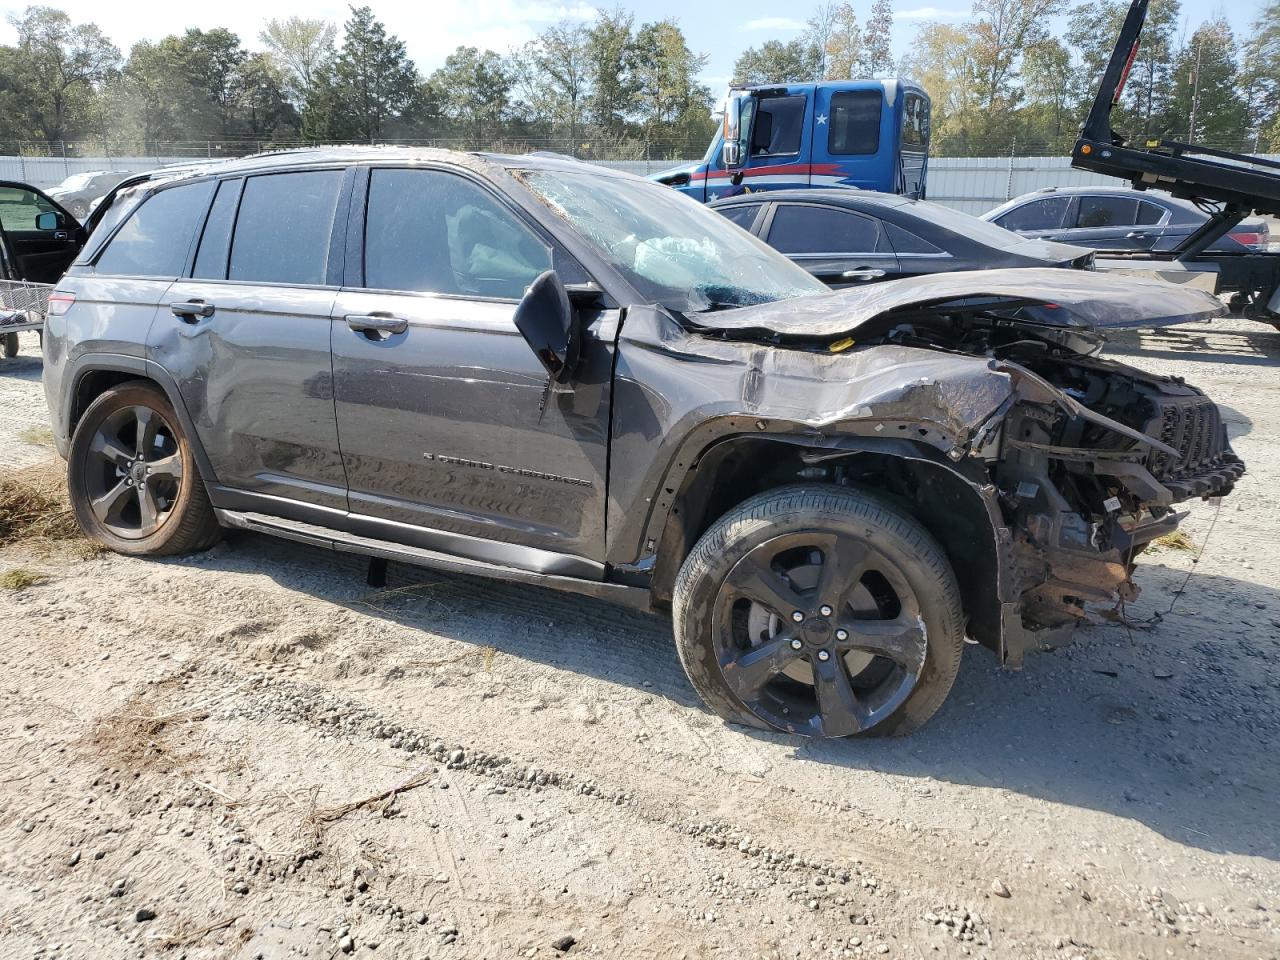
[333,168,617,577]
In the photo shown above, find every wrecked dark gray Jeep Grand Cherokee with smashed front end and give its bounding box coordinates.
[45,148,1243,736]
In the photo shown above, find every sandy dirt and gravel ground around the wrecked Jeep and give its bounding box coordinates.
[0,320,1280,960]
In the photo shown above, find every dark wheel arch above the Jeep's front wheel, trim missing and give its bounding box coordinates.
[652,434,1007,658]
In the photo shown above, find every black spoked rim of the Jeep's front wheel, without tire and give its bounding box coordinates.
[713,531,928,737]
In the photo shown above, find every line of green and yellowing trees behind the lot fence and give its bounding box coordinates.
[0,0,1280,159]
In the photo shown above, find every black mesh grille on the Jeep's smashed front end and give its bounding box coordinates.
[1147,394,1244,499]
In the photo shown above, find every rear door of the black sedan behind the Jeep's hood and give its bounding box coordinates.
[765,204,900,288]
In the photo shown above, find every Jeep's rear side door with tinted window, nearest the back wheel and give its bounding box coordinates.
[151,168,353,521]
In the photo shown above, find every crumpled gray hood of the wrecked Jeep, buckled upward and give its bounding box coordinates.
[689,268,1226,337]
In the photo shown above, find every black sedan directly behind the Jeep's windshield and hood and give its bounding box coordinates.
[709,188,1093,287]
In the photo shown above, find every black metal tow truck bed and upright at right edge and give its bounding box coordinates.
[1071,0,1280,329]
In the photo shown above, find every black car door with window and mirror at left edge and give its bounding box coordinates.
[0,180,84,283]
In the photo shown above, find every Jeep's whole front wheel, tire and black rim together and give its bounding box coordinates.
[673,485,965,737]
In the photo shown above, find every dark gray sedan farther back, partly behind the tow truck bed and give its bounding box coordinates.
[982,187,1271,253]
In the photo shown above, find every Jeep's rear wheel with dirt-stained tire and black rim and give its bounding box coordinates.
[67,380,221,557]
